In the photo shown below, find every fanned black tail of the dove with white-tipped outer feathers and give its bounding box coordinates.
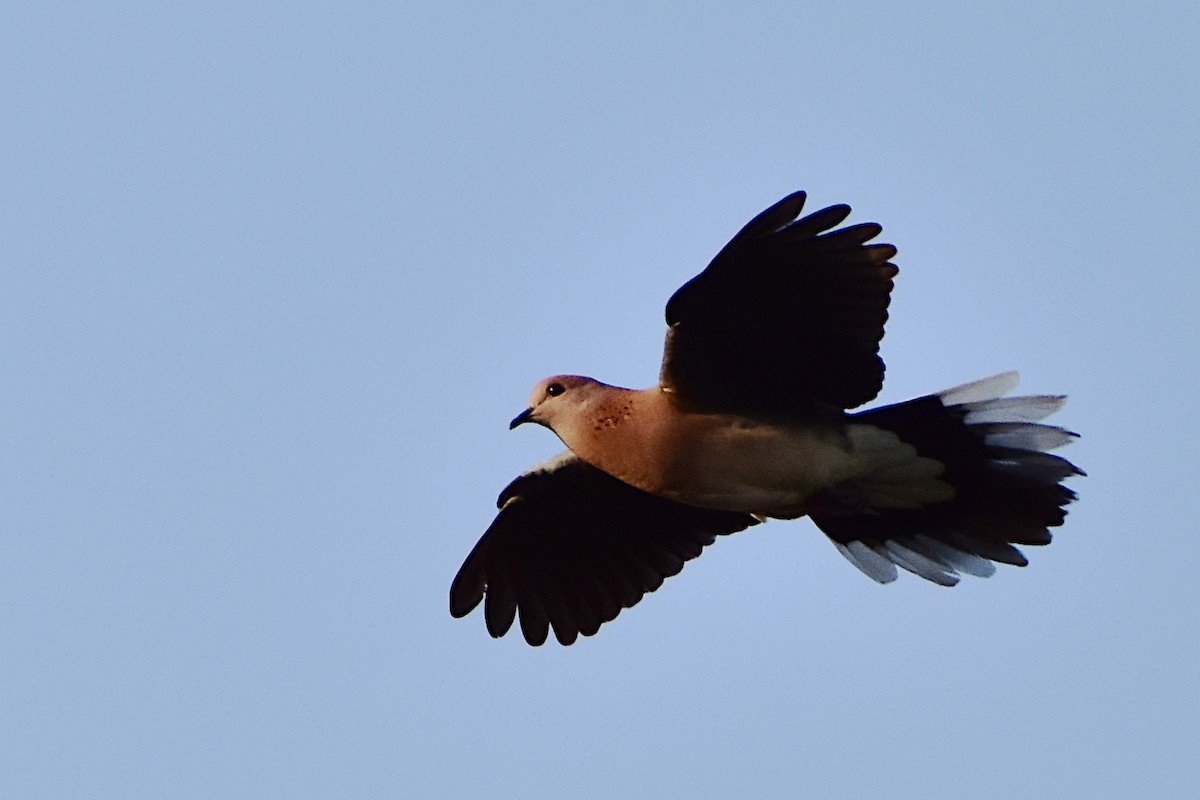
[810,373,1084,585]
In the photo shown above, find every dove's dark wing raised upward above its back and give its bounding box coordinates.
[661,192,898,419]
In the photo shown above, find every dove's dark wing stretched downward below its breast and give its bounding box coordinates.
[450,453,756,644]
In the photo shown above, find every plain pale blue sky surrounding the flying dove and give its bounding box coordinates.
[0,1,1200,799]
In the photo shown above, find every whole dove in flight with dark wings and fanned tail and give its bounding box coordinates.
[450,192,1084,645]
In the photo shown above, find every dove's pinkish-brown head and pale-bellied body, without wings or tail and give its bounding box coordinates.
[528,375,953,519]
